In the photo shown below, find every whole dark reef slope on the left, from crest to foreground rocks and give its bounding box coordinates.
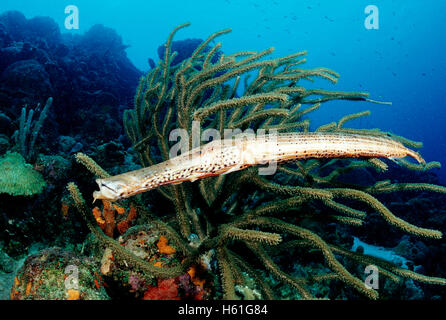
[0,11,142,258]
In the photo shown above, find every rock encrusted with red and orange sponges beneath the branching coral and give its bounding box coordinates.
[96,225,213,300]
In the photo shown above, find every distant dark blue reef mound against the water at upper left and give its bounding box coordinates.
[0,11,141,146]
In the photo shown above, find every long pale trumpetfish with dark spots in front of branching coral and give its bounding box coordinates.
[93,132,424,201]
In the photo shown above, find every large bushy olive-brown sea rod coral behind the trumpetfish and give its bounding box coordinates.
[68,24,446,299]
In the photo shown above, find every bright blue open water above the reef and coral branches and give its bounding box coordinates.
[0,0,446,183]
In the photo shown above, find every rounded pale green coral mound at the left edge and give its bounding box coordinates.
[0,152,46,196]
